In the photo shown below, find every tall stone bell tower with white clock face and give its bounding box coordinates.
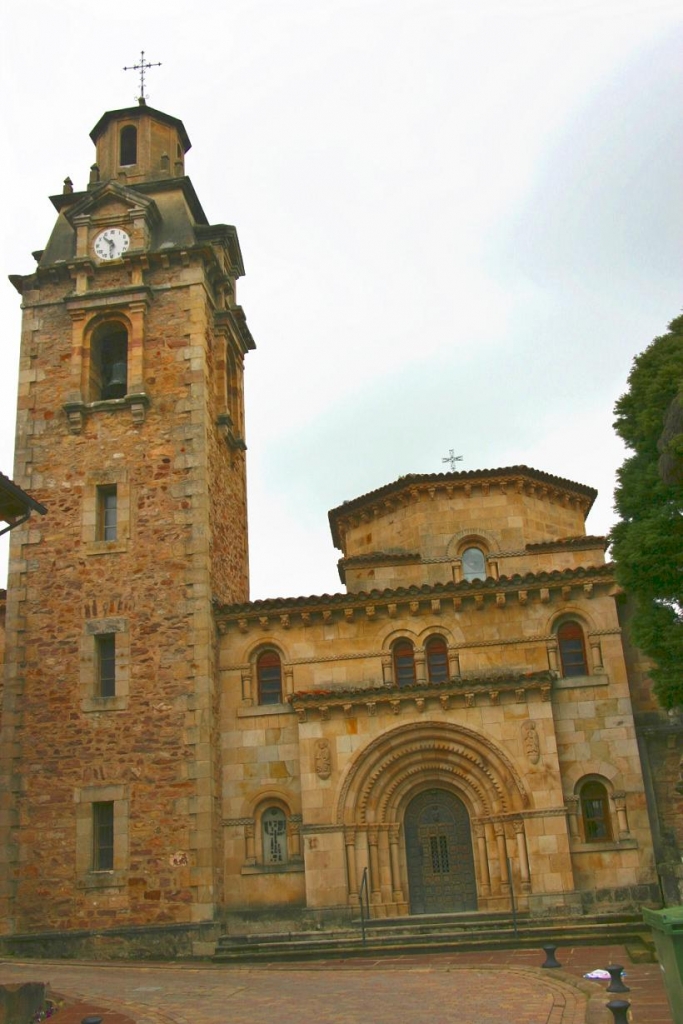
[0,99,254,941]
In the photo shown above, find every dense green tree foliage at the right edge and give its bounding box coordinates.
[611,316,683,708]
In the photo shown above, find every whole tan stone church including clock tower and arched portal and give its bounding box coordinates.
[0,100,683,955]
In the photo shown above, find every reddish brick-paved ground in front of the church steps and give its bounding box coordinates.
[0,945,680,1024]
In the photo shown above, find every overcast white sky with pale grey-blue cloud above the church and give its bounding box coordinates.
[0,0,683,598]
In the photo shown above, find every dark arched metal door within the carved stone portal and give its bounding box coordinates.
[403,790,477,913]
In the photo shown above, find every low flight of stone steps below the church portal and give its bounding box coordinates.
[213,915,649,963]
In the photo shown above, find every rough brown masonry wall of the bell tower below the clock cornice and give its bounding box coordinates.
[3,243,245,931]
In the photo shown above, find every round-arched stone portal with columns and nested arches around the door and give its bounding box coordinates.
[337,721,530,918]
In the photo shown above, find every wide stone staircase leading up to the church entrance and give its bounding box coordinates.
[213,913,653,964]
